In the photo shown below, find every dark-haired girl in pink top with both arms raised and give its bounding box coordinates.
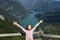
[13,20,43,40]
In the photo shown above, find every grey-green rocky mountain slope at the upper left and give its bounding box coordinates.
[0,0,29,19]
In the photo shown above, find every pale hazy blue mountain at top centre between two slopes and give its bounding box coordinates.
[20,0,37,10]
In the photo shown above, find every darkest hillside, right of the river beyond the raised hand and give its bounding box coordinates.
[35,12,60,23]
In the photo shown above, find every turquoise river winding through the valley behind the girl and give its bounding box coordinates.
[19,11,43,28]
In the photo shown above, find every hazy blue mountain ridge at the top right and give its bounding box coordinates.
[31,0,60,12]
